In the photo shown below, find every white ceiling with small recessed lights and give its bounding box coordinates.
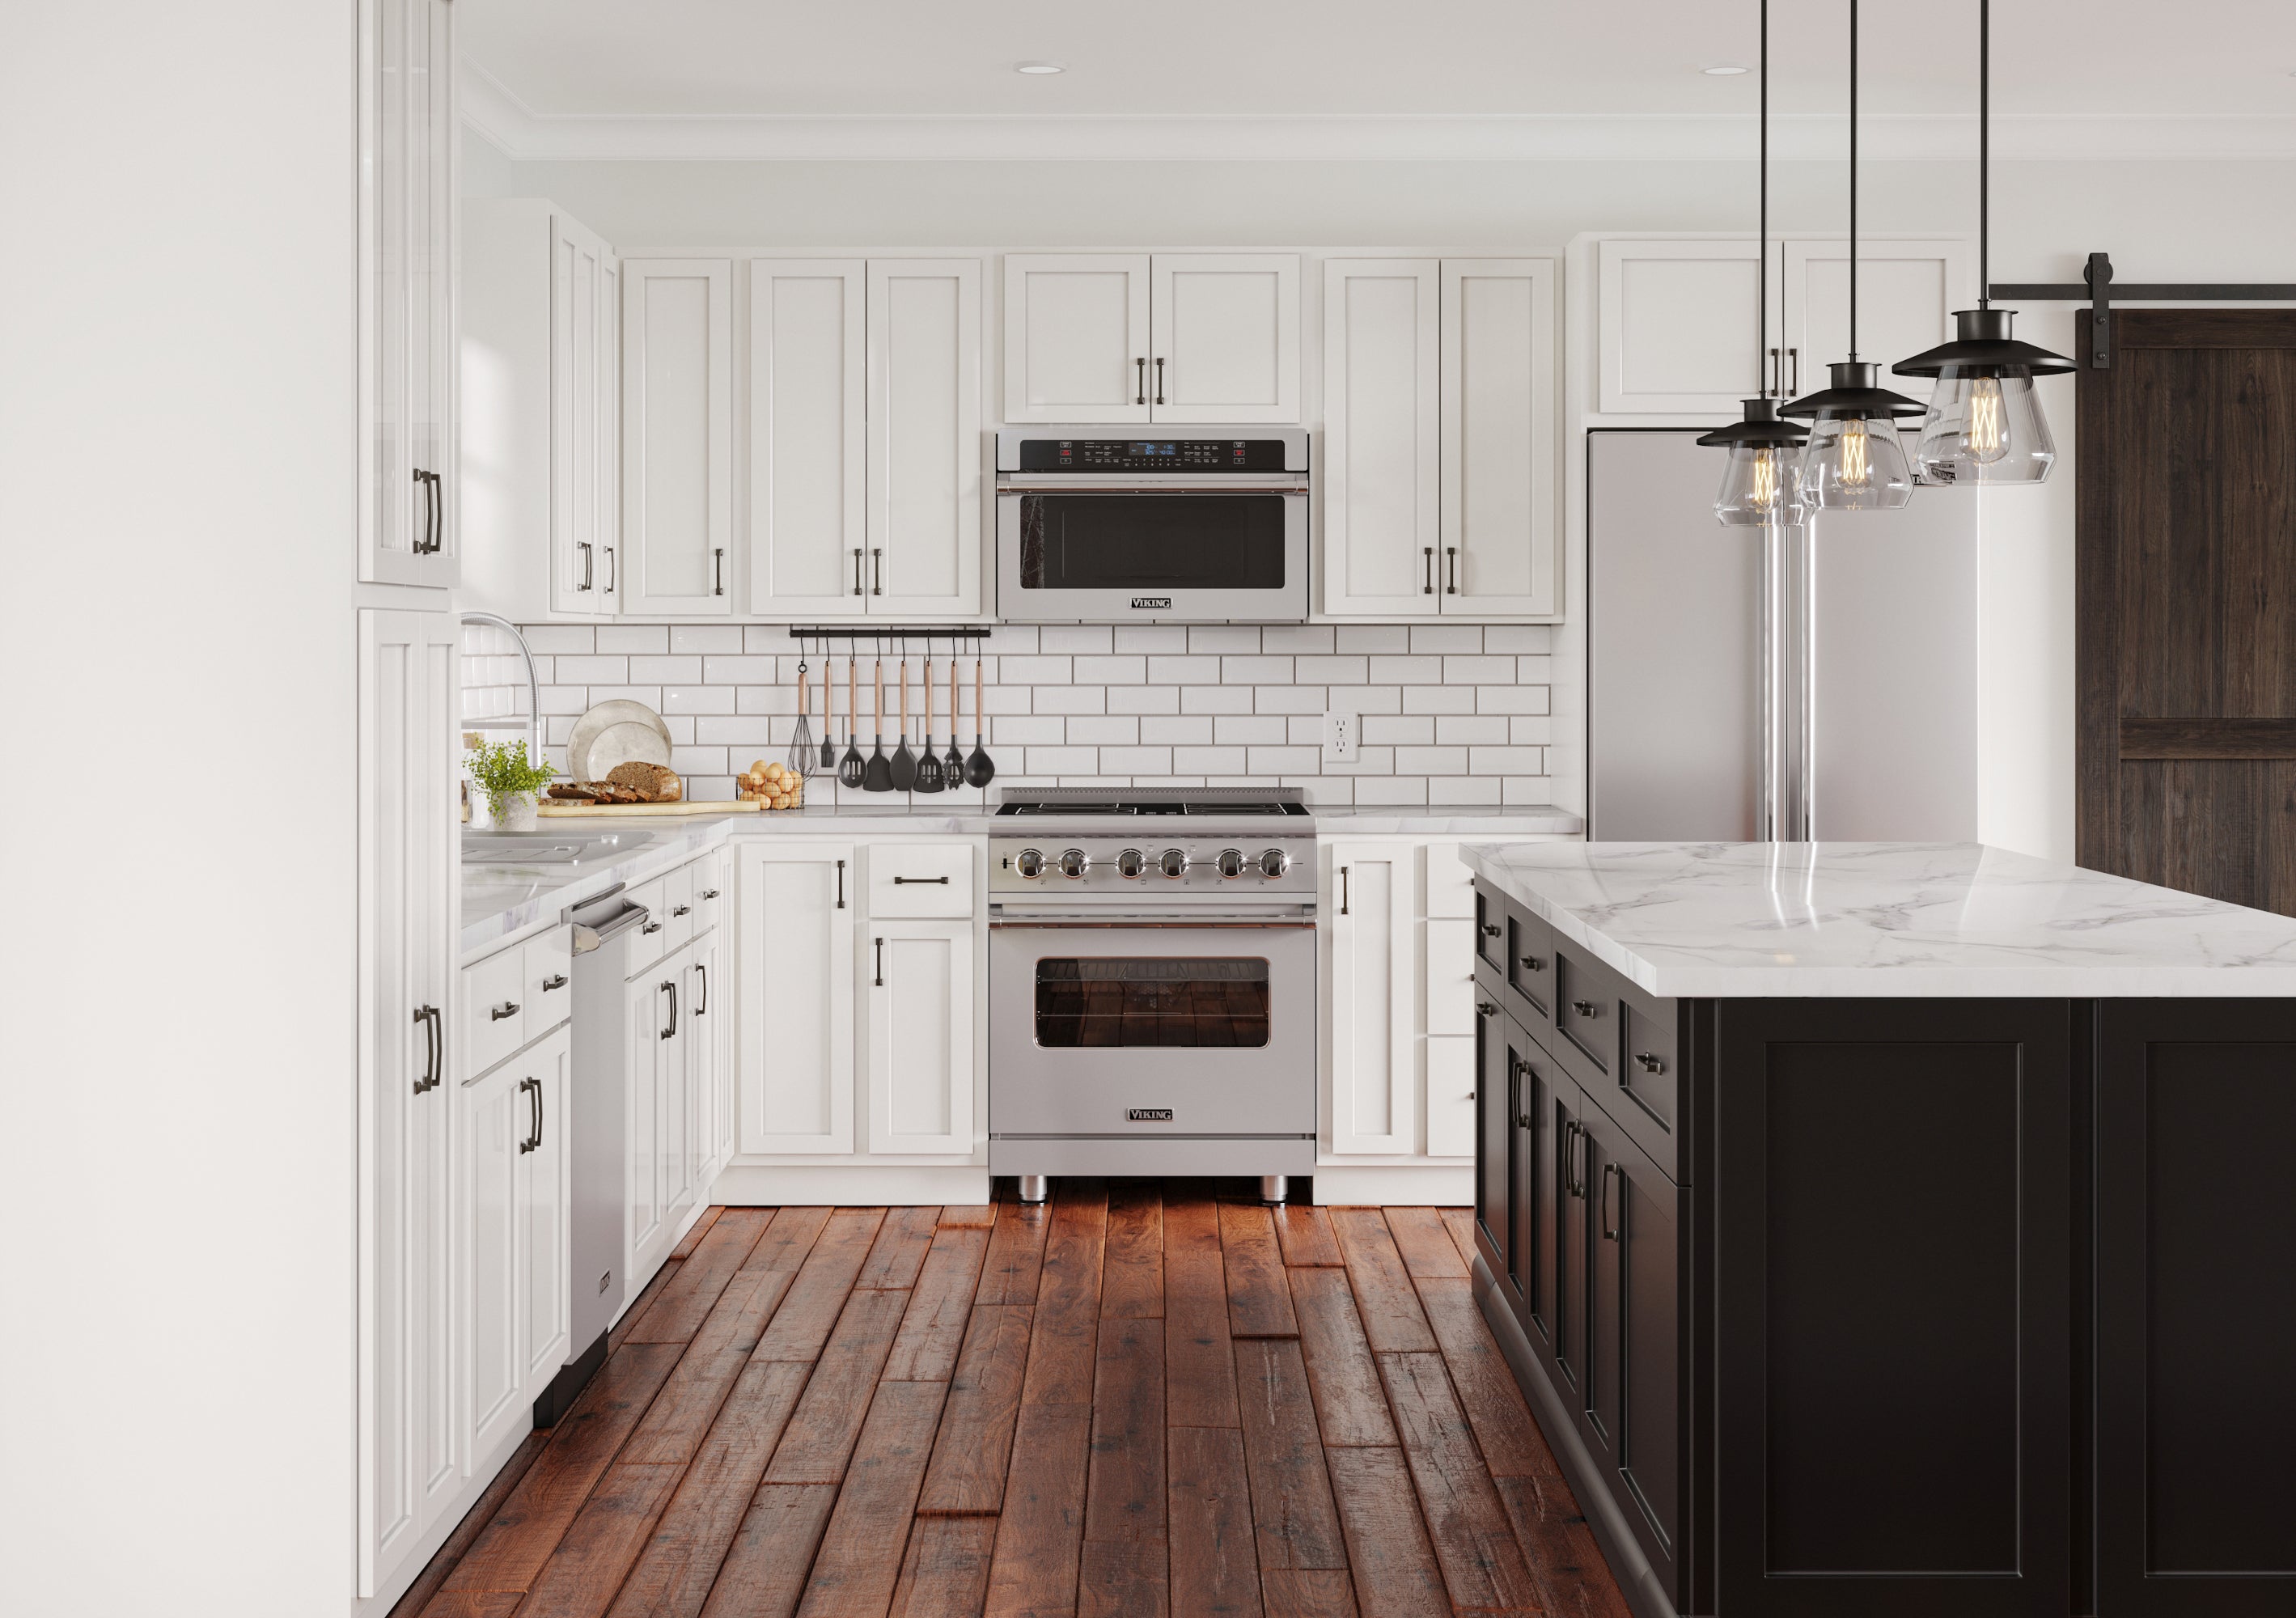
[457,0,2296,156]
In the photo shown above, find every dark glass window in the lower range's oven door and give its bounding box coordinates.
[1036,955,1268,1048]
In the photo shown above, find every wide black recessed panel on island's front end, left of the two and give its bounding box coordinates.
[1713,998,2075,1618]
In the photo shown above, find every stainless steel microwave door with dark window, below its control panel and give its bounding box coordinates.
[997,475,1309,625]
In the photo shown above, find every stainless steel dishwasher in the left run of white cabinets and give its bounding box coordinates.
[535,881,645,1428]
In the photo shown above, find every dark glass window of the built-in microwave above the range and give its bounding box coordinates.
[1019,493,1295,595]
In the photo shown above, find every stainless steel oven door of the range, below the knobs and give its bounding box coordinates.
[989,921,1315,1141]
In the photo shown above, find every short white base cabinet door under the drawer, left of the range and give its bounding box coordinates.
[861,921,976,1152]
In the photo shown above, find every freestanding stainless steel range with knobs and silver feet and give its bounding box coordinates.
[989,787,1315,1201]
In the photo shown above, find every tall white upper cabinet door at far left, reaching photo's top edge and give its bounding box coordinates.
[358,0,460,587]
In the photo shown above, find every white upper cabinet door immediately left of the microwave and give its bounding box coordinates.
[863,260,981,617]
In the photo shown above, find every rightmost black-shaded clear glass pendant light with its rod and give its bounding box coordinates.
[1896,0,2074,486]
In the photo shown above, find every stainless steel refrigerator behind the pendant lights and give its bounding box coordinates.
[1586,429,1977,842]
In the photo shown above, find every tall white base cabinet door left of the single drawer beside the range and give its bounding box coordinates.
[735,840,858,1154]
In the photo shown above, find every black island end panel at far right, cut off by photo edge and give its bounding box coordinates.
[2096,1001,2296,1618]
